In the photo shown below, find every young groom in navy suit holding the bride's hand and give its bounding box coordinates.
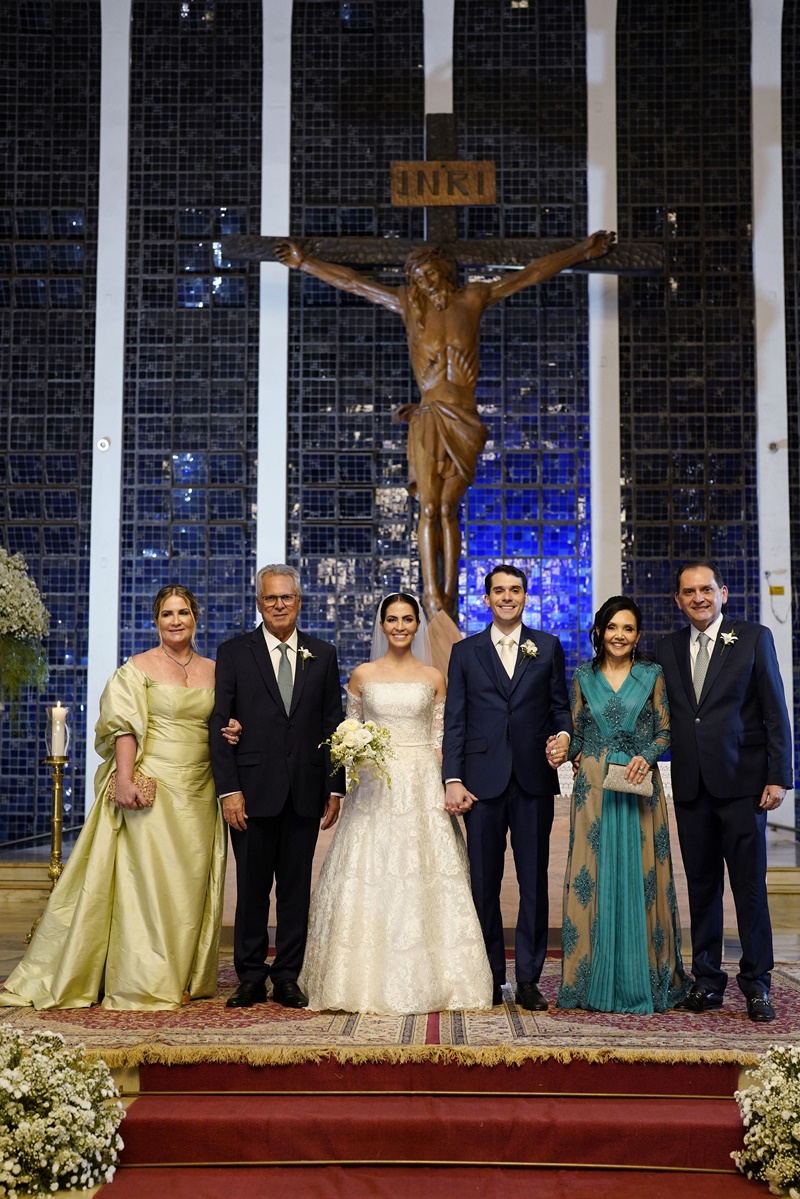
[443,565,572,1012]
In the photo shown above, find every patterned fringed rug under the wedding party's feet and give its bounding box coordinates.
[0,960,800,1067]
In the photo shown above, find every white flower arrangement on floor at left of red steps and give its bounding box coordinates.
[0,1029,125,1199]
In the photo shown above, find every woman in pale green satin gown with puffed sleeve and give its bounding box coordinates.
[0,585,237,1011]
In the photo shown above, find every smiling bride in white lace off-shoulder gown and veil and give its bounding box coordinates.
[299,592,492,1014]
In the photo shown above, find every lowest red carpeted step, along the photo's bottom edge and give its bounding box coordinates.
[98,1165,768,1199]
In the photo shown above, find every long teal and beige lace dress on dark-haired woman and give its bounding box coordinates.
[558,662,691,1013]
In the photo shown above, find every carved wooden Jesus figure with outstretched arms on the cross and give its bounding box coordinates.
[275,230,614,617]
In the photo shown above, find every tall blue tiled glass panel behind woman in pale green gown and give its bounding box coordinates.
[120,0,261,661]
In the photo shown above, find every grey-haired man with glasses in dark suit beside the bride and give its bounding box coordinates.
[209,565,344,1007]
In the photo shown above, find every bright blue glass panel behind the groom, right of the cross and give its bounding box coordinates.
[455,0,591,669]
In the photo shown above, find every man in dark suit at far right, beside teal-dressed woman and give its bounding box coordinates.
[656,559,793,1023]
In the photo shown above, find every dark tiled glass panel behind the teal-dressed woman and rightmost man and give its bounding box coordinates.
[616,0,759,646]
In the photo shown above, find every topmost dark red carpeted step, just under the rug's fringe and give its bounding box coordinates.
[139,1055,739,1097]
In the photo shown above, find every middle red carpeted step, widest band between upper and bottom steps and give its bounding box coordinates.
[122,1093,741,1170]
